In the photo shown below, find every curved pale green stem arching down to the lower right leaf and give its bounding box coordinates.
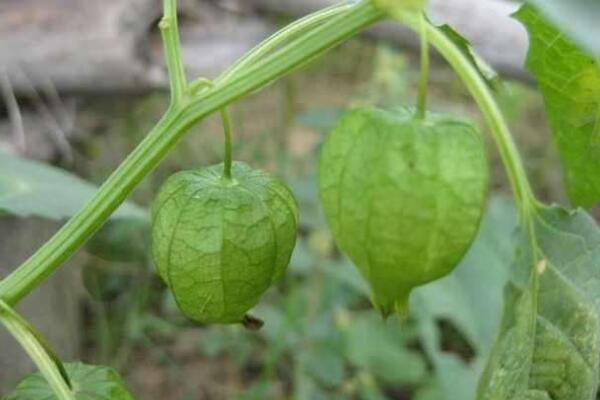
[400,15,537,220]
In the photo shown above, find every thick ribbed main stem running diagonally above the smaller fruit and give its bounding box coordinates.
[0,0,384,305]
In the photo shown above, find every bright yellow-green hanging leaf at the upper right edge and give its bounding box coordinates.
[516,6,600,207]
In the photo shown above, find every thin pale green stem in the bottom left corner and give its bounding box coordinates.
[0,301,75,400]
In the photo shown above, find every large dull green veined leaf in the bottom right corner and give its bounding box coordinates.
[478,207,600,400]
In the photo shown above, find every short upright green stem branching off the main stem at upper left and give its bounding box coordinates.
[158,0,187,105]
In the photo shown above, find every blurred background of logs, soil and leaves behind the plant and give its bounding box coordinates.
[0,0,564,400]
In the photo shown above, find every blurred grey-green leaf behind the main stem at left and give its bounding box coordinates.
[0,152,148,220]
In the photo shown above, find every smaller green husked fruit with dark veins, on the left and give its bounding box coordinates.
[152,162,298,323]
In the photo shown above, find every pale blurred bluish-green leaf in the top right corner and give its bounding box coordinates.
[528,0,600,56]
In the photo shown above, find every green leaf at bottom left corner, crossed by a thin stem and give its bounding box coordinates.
[3,362,134,400]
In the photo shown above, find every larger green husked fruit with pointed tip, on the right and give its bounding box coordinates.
[319,109,488,316]
